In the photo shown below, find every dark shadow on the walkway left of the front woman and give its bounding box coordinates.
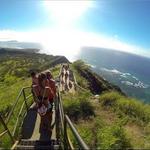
[22,109,37,139]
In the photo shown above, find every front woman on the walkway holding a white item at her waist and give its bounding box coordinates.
[33,73,54,133]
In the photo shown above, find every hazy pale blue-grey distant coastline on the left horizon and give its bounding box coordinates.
[0,40,43,49]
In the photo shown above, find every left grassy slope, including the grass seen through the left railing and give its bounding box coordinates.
[0,51,66,148]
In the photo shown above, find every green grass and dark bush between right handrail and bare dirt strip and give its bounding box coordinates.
[62,91,131,149]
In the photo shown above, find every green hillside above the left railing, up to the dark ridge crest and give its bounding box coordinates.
[0,48,68,115]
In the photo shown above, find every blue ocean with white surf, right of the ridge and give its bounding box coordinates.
[78,47,150,102]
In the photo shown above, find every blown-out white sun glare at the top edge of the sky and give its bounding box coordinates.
[44,0,92,27]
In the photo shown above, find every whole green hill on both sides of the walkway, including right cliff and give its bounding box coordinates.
[0,49,150,149]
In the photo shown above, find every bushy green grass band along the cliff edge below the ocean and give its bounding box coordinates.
[99,91,150,124]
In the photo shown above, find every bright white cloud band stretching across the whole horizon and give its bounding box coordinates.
[0,28,150,57]
